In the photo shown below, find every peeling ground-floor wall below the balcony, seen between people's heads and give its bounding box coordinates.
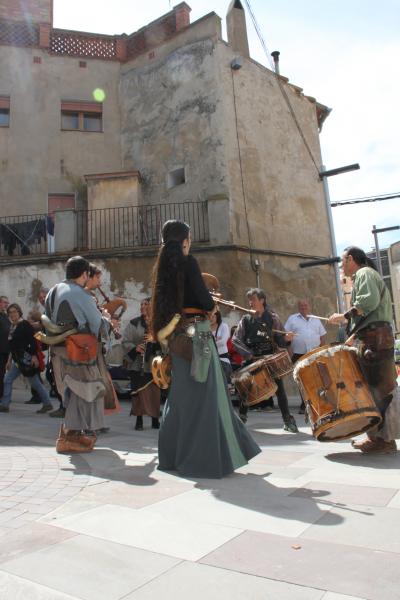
[0,246,334,332]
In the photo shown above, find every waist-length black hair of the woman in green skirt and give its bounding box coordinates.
[150,220,190,337]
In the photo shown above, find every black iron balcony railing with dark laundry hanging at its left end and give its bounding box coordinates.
[0,202,209,258]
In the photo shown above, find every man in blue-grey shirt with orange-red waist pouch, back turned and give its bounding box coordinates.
[42,256,110,453]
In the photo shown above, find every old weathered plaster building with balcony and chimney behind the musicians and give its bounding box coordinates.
[0,0,335,328]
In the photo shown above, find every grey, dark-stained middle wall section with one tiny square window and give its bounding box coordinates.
[120,19,227,211]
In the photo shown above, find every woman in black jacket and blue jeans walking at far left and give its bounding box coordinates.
[0,303,53,414]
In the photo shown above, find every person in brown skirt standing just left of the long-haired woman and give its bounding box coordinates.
[122,298,161,431]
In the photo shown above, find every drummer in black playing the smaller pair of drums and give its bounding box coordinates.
[232,288,299,433]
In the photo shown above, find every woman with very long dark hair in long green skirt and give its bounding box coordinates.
[151,221,260,478]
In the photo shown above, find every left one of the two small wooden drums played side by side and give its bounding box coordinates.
[232,358,278,406]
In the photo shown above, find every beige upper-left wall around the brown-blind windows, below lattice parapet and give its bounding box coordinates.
[0,46,121,216]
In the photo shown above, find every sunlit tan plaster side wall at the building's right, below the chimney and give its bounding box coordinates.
[215,42,329,255]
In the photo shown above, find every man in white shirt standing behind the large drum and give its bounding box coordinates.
[285,299,326,414]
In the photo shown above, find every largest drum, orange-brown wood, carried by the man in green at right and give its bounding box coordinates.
[293,345,382,442]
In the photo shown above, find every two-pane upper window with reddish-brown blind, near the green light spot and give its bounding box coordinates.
[61,101,103,132]
